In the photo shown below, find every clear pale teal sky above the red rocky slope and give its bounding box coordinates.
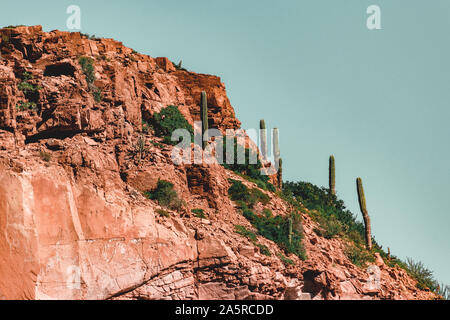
[0,0,450,284]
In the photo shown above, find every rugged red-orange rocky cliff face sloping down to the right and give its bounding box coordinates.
[0,26,434,299]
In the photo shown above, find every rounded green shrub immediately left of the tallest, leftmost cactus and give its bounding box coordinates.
[150,106,194,145]
